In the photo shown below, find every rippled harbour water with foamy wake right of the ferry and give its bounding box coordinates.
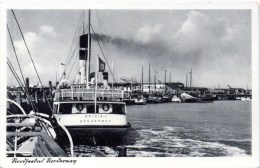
[66,101,252,157]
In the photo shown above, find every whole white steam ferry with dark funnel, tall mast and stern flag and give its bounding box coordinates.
[53,10,130,140]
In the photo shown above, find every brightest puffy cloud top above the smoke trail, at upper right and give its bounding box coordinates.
[173,11,225,58]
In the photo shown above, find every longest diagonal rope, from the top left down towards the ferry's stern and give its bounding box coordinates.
[11,9,52,111]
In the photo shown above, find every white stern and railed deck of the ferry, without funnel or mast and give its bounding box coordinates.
[53,85,130,136]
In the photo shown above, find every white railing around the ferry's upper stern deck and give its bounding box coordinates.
[55,88,124,101]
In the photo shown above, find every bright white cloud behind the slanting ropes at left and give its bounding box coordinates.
[8,25,58,84]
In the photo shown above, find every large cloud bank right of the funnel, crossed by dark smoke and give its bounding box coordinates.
[94,11,251,86]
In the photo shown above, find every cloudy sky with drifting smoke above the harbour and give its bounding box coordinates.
[7,10,252,89]
